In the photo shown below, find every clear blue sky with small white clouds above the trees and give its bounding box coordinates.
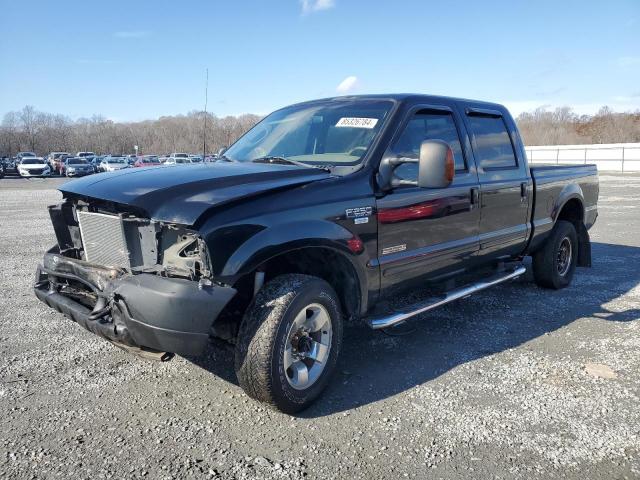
[0,0,640,121]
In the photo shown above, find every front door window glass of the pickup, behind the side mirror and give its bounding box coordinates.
[390,112,467,181]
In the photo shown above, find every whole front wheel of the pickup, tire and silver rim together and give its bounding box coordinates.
[235,274,342,413]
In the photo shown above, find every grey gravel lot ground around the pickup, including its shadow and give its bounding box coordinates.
[0,175,640,479]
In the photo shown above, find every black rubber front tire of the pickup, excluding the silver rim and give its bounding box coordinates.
[235,274,343,414]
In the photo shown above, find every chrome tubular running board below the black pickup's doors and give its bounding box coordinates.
[367,265,527,330]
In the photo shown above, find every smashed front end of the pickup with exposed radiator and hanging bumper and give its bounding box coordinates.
[35,199,236,359]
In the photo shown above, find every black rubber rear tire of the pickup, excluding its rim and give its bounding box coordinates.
[533,220,578,290]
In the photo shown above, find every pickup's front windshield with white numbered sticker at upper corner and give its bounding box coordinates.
[224,100,393,166]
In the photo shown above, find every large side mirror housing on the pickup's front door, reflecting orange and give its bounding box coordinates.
[418,140,455,188]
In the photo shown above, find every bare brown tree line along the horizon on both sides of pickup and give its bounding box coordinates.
[0,106,640,156]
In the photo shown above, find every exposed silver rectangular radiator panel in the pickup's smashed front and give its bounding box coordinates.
[78,211,131,268]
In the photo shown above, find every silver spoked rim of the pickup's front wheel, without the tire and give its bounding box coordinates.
[284,303,333,390]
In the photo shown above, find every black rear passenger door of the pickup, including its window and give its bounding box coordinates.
[464,105,531,259]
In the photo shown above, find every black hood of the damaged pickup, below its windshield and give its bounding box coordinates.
[60,163,330,225]
